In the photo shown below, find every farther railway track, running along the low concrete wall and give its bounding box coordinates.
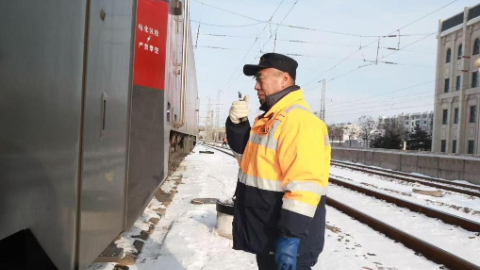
[331,161,480,198]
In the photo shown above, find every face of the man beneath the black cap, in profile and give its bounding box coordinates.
[255,68,289,103]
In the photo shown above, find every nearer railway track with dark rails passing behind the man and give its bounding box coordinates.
[204,145,480,270]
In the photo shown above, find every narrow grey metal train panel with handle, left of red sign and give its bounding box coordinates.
[78,0,134,269]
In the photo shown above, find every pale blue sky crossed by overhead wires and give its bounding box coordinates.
[191,0,479,126]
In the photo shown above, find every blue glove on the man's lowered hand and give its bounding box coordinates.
[275,236,300,270]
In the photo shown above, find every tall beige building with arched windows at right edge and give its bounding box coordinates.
[432,5,480,154]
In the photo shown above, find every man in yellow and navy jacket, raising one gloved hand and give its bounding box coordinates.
[226,53,331,270]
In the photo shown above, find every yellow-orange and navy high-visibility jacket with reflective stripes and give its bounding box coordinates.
[227,87,331,263]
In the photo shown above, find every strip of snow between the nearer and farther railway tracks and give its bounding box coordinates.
[330,166,480,222]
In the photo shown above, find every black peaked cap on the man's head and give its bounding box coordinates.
[243,53,298,80]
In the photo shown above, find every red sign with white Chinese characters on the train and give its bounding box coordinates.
[133,0,168,90]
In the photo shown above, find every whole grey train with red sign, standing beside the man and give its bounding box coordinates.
[0,0,198,270]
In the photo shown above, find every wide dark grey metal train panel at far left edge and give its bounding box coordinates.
[0,0,86,269]
